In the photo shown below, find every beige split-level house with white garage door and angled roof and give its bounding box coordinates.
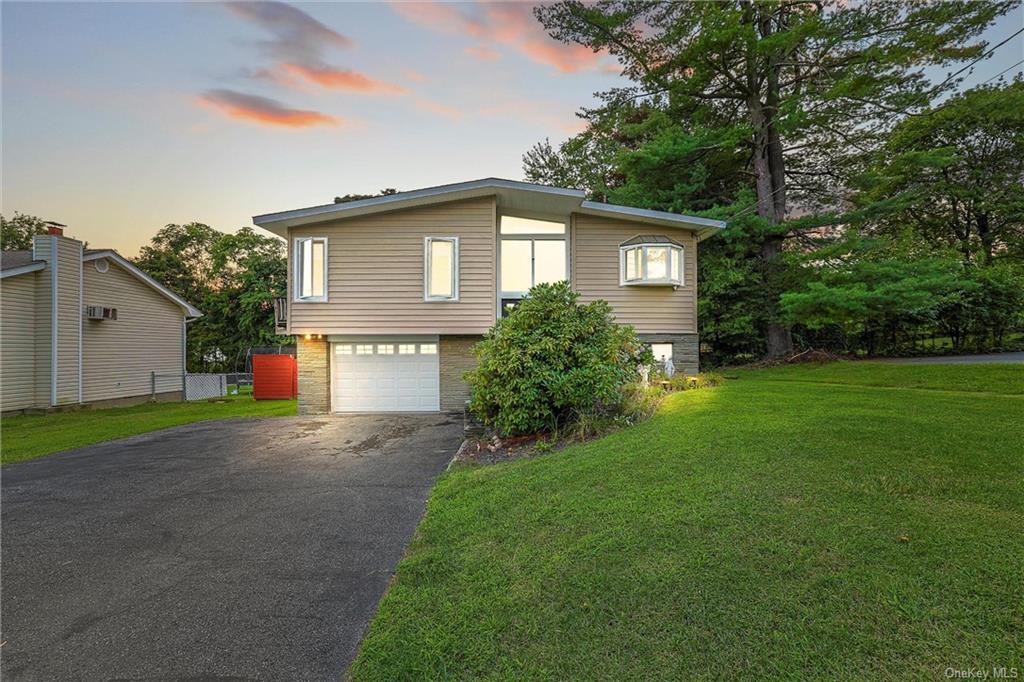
[253,178,725,414]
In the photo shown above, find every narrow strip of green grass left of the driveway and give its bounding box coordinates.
[0,394,295,464]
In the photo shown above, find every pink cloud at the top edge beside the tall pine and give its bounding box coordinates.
[391,1,604,73]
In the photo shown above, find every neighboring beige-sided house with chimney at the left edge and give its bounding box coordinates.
[0,227,202,412]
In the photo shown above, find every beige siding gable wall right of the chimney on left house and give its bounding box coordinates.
[82,259,184,402]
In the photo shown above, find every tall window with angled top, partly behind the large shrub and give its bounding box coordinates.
[499,215,569,303]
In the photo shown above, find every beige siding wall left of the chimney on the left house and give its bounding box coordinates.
[0,272,38,412]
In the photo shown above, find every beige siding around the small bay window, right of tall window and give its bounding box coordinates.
[571,214,697,334]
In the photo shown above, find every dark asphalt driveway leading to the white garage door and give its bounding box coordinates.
[2,415,461,680]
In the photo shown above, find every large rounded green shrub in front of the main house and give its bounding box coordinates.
[466,282,650,435]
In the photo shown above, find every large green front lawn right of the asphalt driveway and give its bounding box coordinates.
[351,363,1024,680]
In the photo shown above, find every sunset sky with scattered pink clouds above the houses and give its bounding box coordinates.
[0,2,1024,256]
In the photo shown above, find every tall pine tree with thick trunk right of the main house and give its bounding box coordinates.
[526,0,1017,356]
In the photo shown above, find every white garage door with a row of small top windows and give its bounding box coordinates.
[331,338,440,412]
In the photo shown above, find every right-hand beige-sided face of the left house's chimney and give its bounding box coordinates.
[56,239,82,404]
